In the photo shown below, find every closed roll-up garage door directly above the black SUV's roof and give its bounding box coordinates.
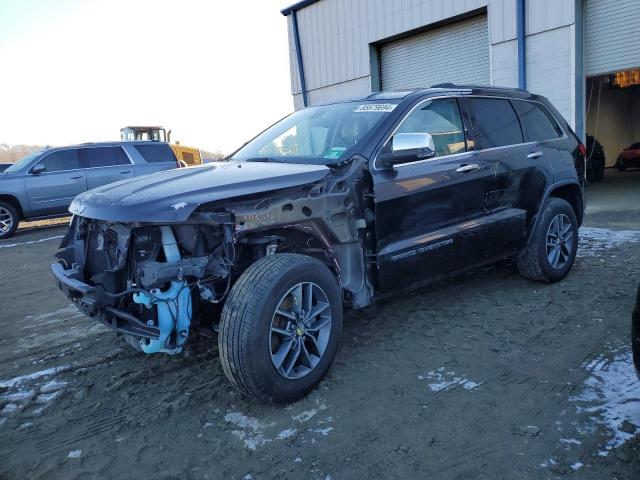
[380,14,490,90]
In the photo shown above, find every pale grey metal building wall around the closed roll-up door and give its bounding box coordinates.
[289,0,576,121]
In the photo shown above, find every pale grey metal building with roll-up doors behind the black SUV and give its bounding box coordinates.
[282,0,640,164]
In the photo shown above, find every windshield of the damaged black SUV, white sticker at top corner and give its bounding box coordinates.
[231,100,399,165]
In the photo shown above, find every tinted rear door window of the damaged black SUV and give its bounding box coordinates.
[467,98,523,149]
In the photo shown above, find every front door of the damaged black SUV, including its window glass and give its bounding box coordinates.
[373,98,486,291]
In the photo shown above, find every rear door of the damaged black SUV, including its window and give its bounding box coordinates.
[462,97,533,261]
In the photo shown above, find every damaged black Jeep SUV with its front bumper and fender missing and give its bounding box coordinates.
[52,84,585,402]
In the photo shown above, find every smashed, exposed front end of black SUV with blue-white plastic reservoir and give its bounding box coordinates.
[52,214,235,354]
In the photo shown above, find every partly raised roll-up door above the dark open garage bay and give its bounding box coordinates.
[584,0,640,76]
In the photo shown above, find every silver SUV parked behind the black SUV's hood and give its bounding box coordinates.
[0,142,180,239]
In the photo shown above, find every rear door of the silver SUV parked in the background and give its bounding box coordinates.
[82,146,134,189]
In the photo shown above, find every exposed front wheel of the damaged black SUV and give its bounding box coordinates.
[218,253,342,402]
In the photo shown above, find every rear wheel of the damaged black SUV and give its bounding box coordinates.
[518,197,578,282]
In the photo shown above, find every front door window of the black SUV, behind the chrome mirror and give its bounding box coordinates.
[396,98,467,157]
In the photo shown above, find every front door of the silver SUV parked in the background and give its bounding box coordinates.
[25,149,87,216]
